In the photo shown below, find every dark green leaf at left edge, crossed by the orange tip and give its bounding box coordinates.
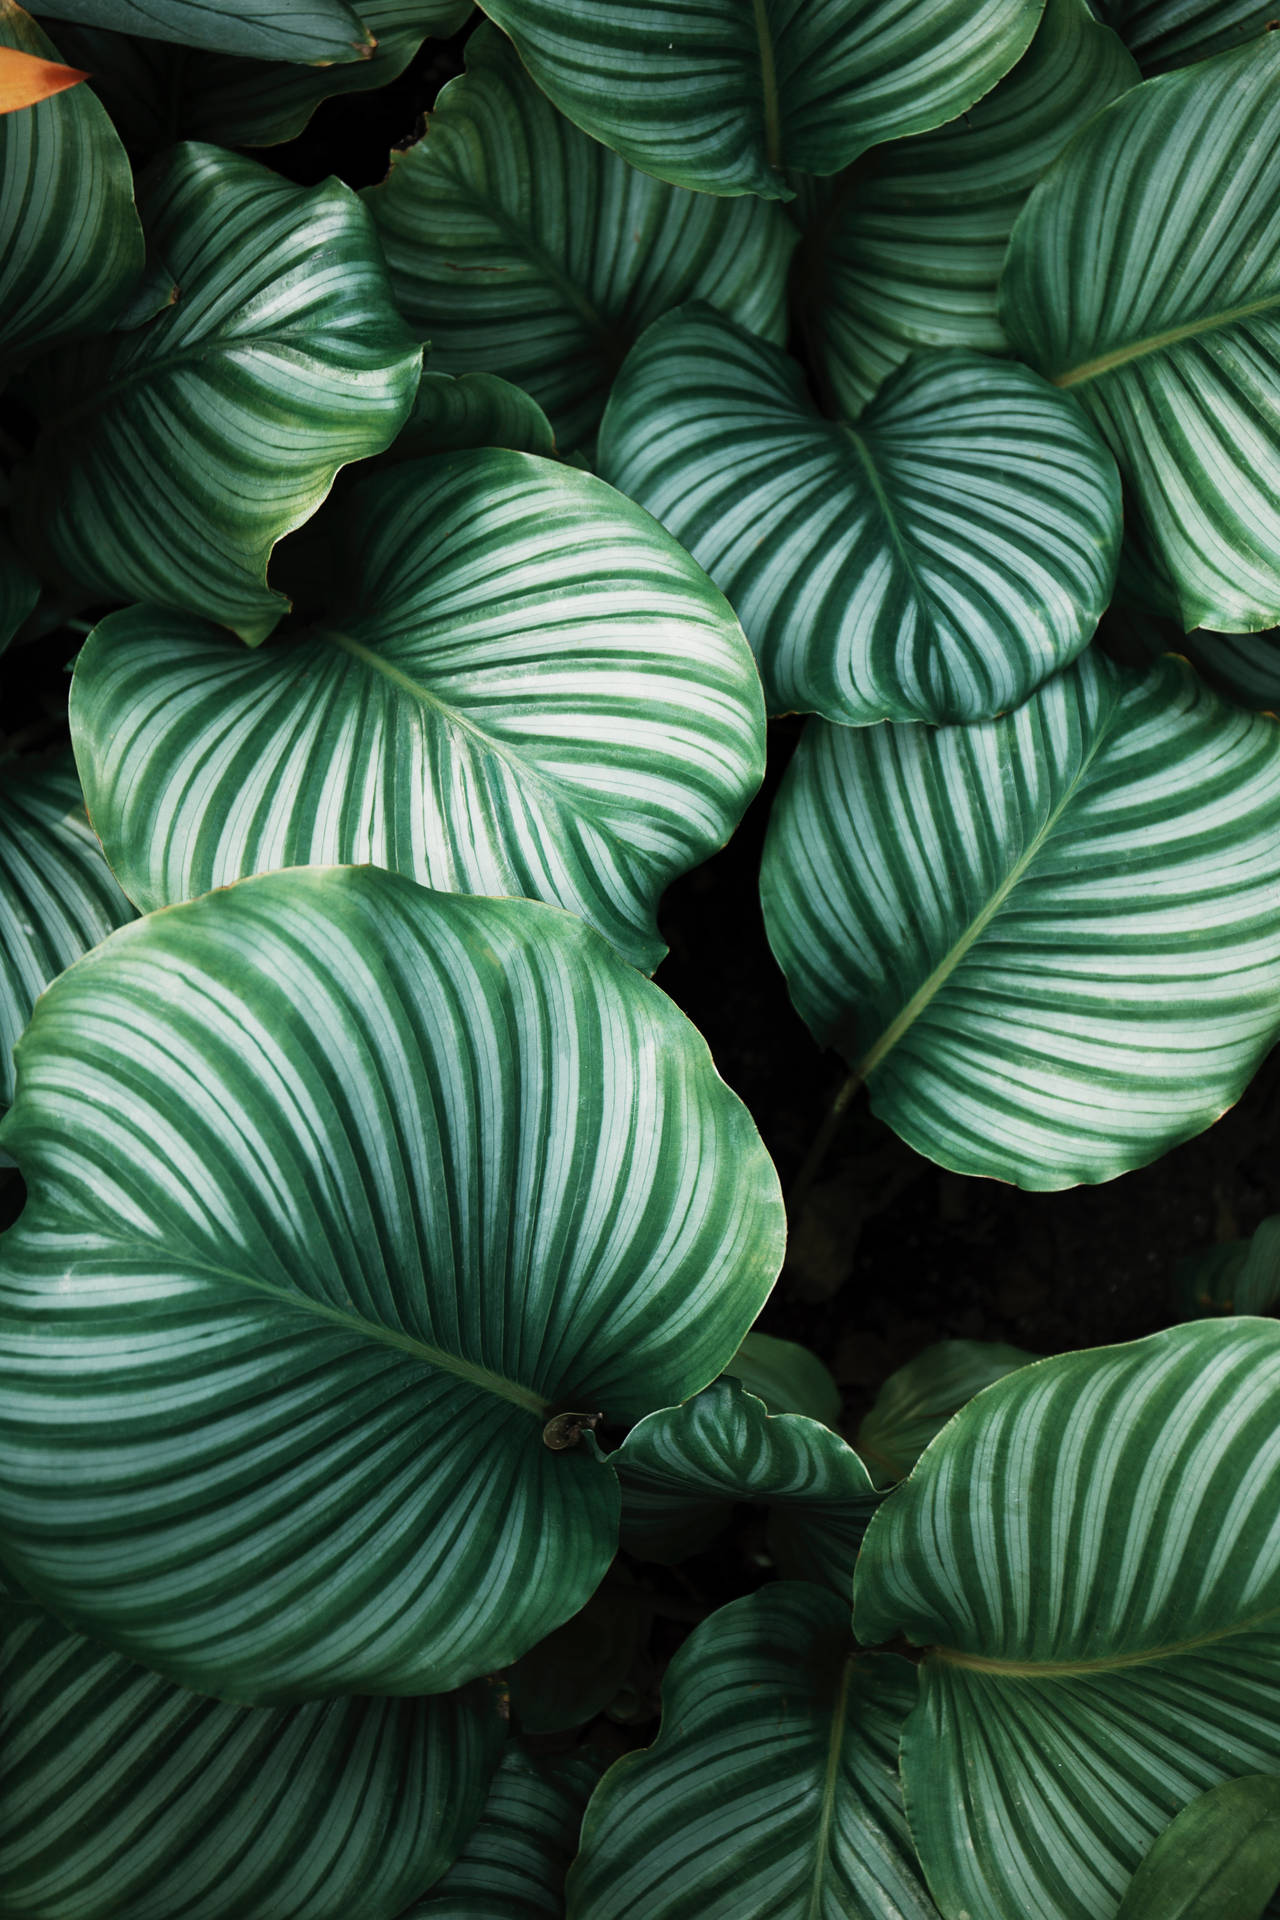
[0,6,144,363]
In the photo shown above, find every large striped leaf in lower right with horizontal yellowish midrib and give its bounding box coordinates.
[854,1319,1280,1920]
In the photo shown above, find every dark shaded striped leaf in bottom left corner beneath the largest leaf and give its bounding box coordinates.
[0,1615,505,1920]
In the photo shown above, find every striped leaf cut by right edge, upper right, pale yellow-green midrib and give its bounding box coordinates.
[1000,36,1280,632]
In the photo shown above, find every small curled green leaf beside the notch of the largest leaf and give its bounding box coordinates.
[610,1380,879,1594]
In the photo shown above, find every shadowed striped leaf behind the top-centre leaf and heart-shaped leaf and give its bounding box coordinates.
[796,0,1138,419]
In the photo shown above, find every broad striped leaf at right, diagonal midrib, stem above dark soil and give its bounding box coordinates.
[760,653,1280,1188]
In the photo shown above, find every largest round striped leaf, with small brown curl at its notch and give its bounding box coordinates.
[0,868,783,1703]
